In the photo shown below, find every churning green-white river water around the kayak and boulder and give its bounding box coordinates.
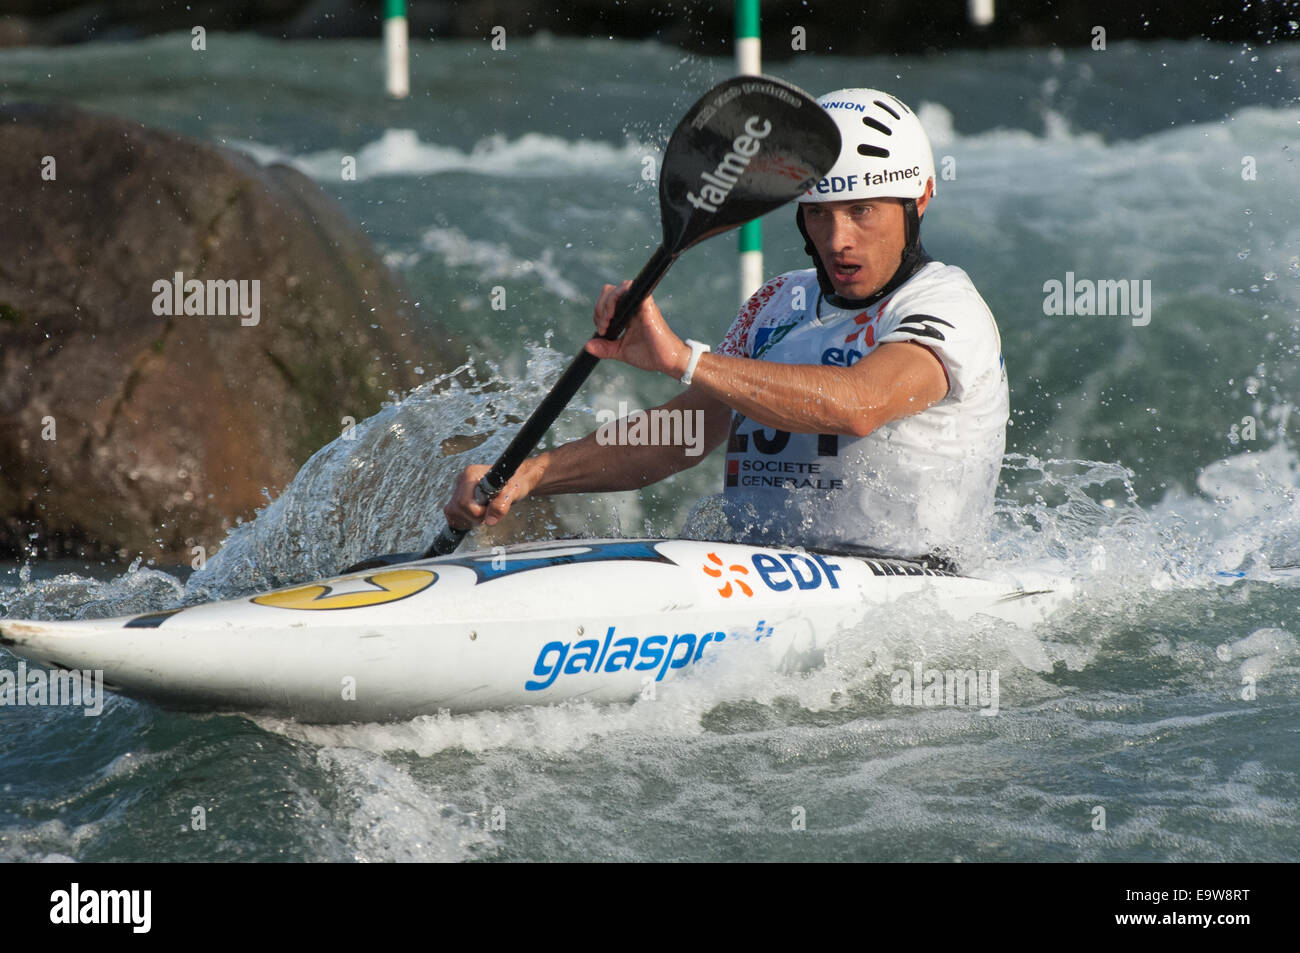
[0,35,1300,862]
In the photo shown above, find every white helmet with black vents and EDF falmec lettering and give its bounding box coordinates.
[800,90,935,203]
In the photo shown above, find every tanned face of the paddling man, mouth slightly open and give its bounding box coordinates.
[803,194,930,298]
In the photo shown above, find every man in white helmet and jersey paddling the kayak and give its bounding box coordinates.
[445,88,1009,556]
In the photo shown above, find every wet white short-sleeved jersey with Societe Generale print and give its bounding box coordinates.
[718,261,1009,555]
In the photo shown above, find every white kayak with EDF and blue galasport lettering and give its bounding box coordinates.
[0,540,1071,723]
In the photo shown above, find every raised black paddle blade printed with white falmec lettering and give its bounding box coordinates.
[659,75,840,252]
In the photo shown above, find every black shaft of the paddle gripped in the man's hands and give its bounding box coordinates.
[423,244,679,559]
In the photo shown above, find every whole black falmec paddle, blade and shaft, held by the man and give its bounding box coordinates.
[348,75,840,572]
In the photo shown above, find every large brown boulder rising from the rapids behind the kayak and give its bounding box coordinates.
[0,105,449,559]
